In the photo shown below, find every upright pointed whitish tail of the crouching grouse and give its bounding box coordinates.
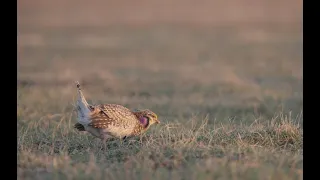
[76,81,91,125]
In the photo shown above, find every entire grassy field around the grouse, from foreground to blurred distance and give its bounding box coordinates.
[17,0,303,180]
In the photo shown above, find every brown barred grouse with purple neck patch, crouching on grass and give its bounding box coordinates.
[74,82,160,141]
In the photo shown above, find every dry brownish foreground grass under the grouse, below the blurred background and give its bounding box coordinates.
[18,112,303,179]
